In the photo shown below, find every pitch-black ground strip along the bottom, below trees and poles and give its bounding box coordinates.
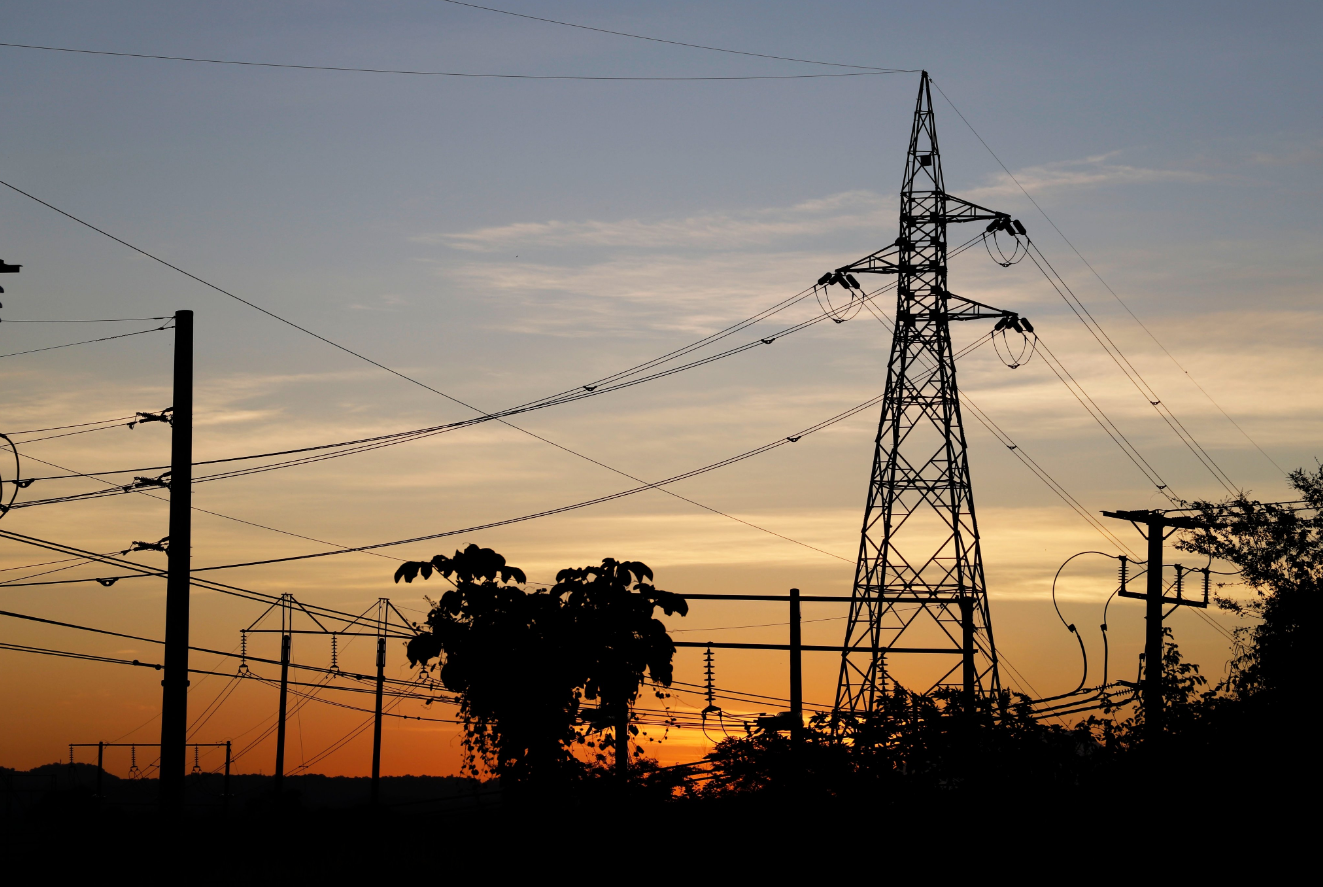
[0,764,1315,884]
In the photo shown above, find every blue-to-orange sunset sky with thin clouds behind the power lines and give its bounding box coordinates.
[0,0,1323,774]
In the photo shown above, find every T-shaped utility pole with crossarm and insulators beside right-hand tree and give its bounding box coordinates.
[1102,511,1208,737]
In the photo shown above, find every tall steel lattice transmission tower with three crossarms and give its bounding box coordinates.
[819,71,1032,714]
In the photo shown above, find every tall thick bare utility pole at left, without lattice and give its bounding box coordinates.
[160,311,193,810]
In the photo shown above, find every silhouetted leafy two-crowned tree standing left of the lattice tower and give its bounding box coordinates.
[396,545,688,786]
